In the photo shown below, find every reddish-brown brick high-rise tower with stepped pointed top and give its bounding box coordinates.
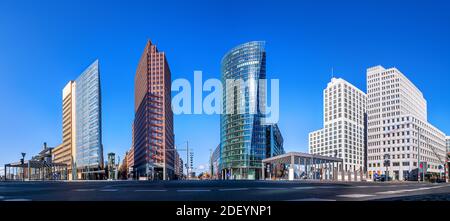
[133,41,175,180]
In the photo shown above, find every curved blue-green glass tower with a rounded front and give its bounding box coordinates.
[220,41,279,179]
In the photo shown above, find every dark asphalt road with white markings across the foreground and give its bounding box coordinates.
[0,181,450,201]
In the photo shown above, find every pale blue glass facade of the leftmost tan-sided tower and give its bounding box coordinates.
[75,60,103,178]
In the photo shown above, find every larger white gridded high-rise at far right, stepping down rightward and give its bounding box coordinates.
[367,66,446,180]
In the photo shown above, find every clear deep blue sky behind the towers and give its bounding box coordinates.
[0,0,450,173]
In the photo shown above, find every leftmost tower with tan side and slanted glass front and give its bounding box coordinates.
[53,60,104,179]
